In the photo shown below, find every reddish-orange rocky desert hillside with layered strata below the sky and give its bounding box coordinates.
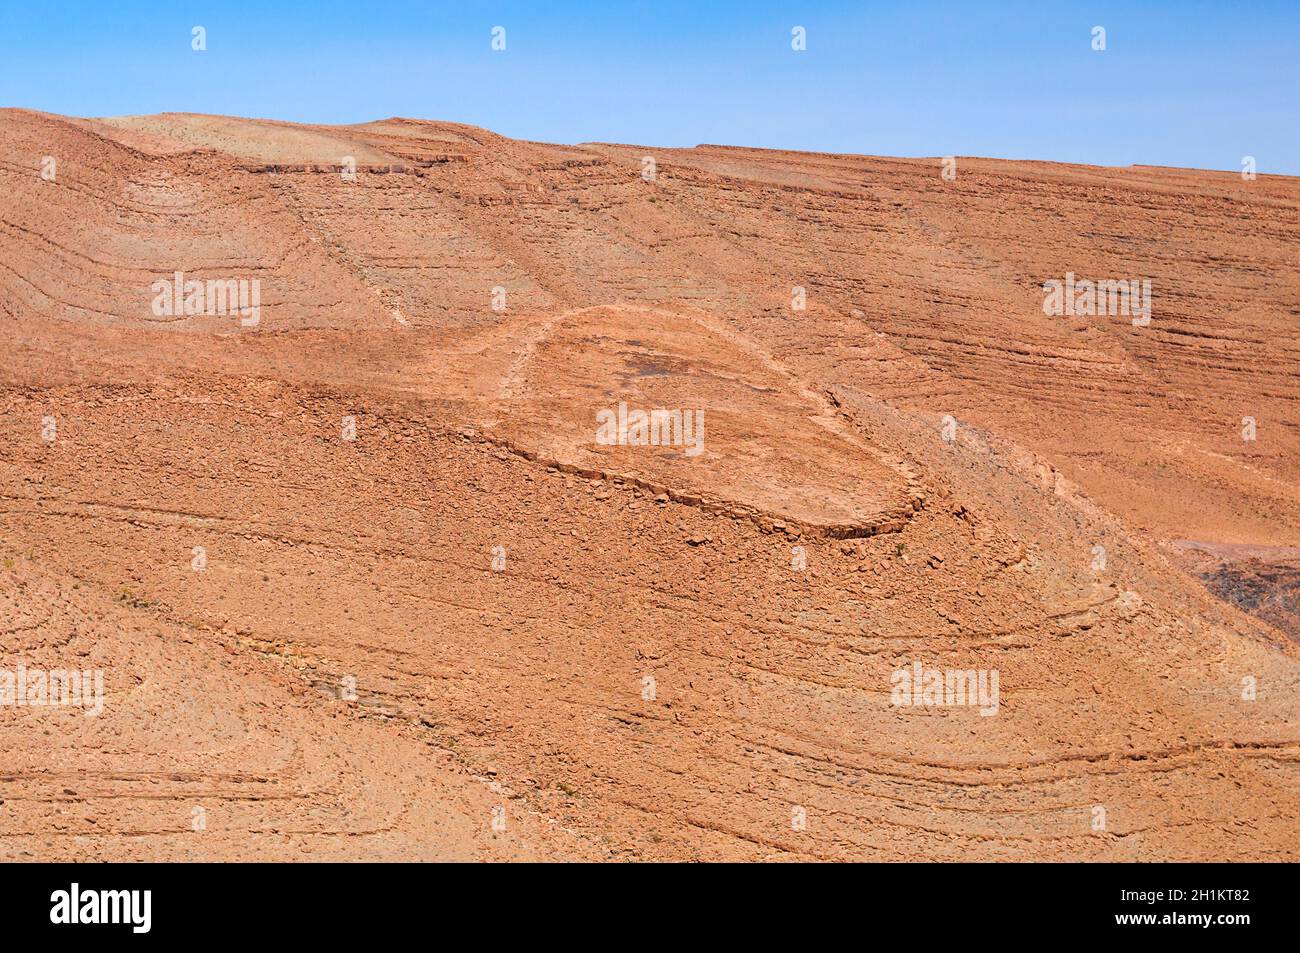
[0,109,1300,861]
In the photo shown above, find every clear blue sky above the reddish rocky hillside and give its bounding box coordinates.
[0,0,1300,174]
